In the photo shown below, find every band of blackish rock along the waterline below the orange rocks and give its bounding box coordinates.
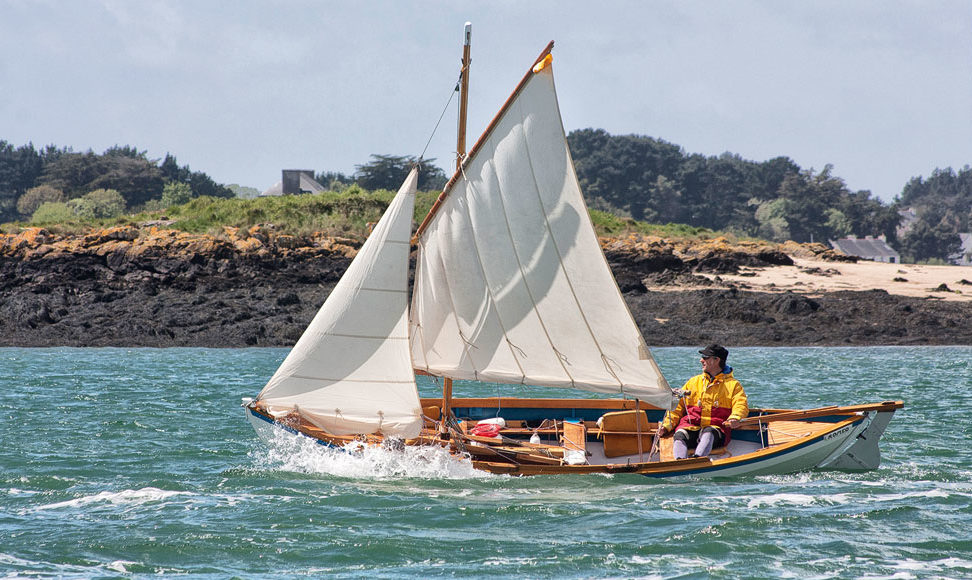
[0,232,972,347]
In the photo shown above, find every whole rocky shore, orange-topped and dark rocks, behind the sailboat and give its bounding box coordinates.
[0,226,972,347]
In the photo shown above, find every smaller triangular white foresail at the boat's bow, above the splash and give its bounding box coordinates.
[258,168,422,437]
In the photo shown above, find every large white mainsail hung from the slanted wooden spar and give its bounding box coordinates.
[411,57,672,408]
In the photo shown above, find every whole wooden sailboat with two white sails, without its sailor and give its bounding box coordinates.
[245,28,903,477]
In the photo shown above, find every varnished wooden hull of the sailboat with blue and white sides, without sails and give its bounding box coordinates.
[246,398,903,479]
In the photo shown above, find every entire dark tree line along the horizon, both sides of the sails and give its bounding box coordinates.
[0,129,972,260]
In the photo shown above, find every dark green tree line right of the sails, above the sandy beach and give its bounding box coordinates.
[567,129,972,260]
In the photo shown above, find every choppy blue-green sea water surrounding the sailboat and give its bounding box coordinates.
[0,346,972,579]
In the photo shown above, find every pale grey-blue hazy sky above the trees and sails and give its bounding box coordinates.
[0,0,972,202]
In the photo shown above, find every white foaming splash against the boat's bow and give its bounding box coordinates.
[250,429,496,479]
